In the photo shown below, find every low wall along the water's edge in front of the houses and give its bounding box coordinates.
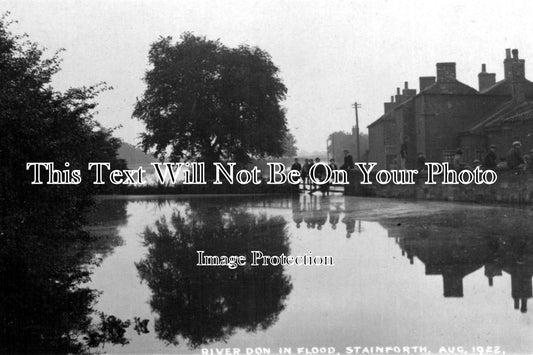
[345,170,533,204]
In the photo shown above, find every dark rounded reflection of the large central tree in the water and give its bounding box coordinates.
[137,204,292,348]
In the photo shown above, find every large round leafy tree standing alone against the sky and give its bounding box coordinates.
[133,33,288,167]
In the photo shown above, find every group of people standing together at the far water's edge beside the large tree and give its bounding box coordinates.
[291,150,355,195]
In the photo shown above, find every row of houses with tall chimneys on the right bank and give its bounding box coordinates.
[368,49,533,169]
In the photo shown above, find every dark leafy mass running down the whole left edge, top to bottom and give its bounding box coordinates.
[0,15,130,353]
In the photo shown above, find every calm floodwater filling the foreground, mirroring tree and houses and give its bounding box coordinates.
[27,195,533,354]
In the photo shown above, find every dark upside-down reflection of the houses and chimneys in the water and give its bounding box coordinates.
[381,211,533,313]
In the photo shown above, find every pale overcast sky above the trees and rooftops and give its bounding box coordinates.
[0,0,533,151]
